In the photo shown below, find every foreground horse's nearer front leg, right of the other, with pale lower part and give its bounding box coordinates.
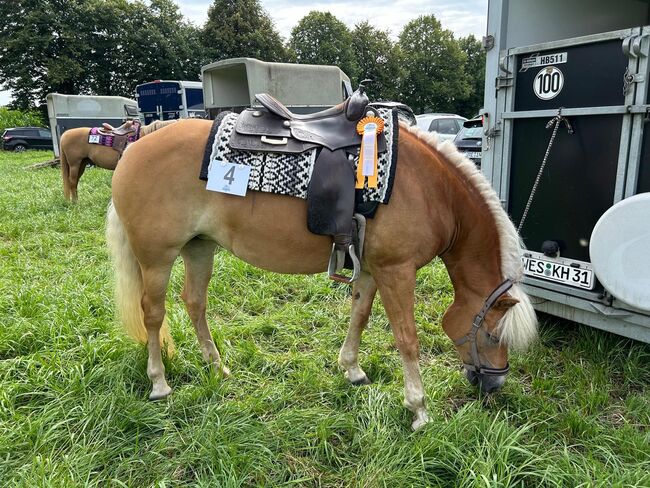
[373,265,429,430]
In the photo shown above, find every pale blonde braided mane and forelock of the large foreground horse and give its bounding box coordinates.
[400,123,537,349]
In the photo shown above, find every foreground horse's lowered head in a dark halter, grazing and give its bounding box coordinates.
[443,280,535,393]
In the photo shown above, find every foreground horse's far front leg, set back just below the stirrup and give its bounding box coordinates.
[339,271,377,385]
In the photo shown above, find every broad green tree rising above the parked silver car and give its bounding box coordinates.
[399,15,469,113]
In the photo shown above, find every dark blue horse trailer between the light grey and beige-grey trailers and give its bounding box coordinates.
[135,80,205,125]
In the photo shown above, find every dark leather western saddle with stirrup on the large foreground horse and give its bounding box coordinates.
[230,82,386,283]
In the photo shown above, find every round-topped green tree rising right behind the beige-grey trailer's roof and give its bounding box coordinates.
[289,11,359,80]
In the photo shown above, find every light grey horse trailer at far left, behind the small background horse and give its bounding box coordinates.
[46,93,138,158]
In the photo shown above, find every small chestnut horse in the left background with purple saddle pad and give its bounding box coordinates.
[60,120,176,202]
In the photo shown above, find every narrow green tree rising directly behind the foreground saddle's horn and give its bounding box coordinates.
[352,22,402,100]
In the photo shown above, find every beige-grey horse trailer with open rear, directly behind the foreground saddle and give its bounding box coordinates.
[201,58,352,118]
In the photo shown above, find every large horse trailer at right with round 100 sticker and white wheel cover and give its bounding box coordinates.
[482,0,650,342]
